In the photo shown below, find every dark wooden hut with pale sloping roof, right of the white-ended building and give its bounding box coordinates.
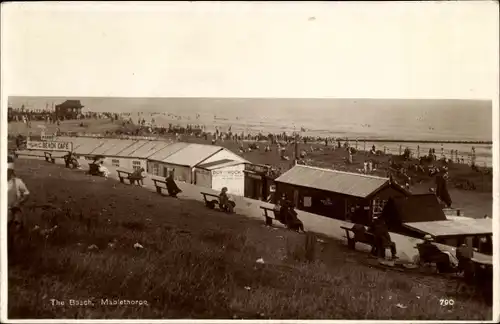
[275,164,410,224]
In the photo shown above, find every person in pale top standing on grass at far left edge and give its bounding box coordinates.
[7,157,30,230]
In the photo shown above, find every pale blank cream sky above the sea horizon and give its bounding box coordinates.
[1,1,499,99]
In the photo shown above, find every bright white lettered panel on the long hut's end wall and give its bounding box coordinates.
[212,164,245,196]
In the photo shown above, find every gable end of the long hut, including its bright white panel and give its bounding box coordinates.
[193,159,245,196]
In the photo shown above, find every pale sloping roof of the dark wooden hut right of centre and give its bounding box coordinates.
[275,165,389,198]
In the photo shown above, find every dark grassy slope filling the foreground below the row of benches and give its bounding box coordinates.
[8,160,491,320]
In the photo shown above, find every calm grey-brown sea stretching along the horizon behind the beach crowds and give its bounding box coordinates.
[9,97,493,167]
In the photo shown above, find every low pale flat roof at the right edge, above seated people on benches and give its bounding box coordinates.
[403,217,493,237]
